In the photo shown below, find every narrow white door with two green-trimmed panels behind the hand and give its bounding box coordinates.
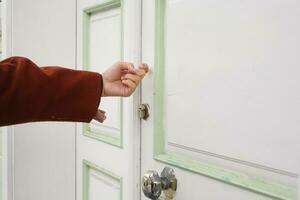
[77,0,141,200]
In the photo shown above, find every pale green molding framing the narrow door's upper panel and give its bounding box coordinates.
[82,0,124,148]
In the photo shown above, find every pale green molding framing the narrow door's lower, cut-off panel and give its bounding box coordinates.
[82,160,123,200]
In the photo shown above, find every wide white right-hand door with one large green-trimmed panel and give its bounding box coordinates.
[141,0,300,200]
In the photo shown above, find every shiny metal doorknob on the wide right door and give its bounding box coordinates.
[142,167,177,200]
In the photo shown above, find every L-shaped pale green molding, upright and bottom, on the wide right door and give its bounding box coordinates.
[154,0,297,200]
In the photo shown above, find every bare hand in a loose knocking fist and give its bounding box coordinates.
[102,62,149,97]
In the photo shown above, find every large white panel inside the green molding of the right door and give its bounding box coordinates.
[165,0,300,173]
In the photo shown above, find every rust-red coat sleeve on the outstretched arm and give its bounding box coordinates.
[0,57,103,126]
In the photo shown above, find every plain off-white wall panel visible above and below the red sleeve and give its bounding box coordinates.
[12,0,76,200]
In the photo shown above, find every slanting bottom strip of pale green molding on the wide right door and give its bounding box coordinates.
[155,154,297,200]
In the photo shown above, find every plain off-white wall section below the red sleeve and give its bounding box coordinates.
[14,123,75,200]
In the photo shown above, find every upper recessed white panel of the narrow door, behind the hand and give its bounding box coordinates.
[84,4,123,146]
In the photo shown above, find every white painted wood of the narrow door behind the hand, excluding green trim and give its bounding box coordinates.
[76,0,140,200]
